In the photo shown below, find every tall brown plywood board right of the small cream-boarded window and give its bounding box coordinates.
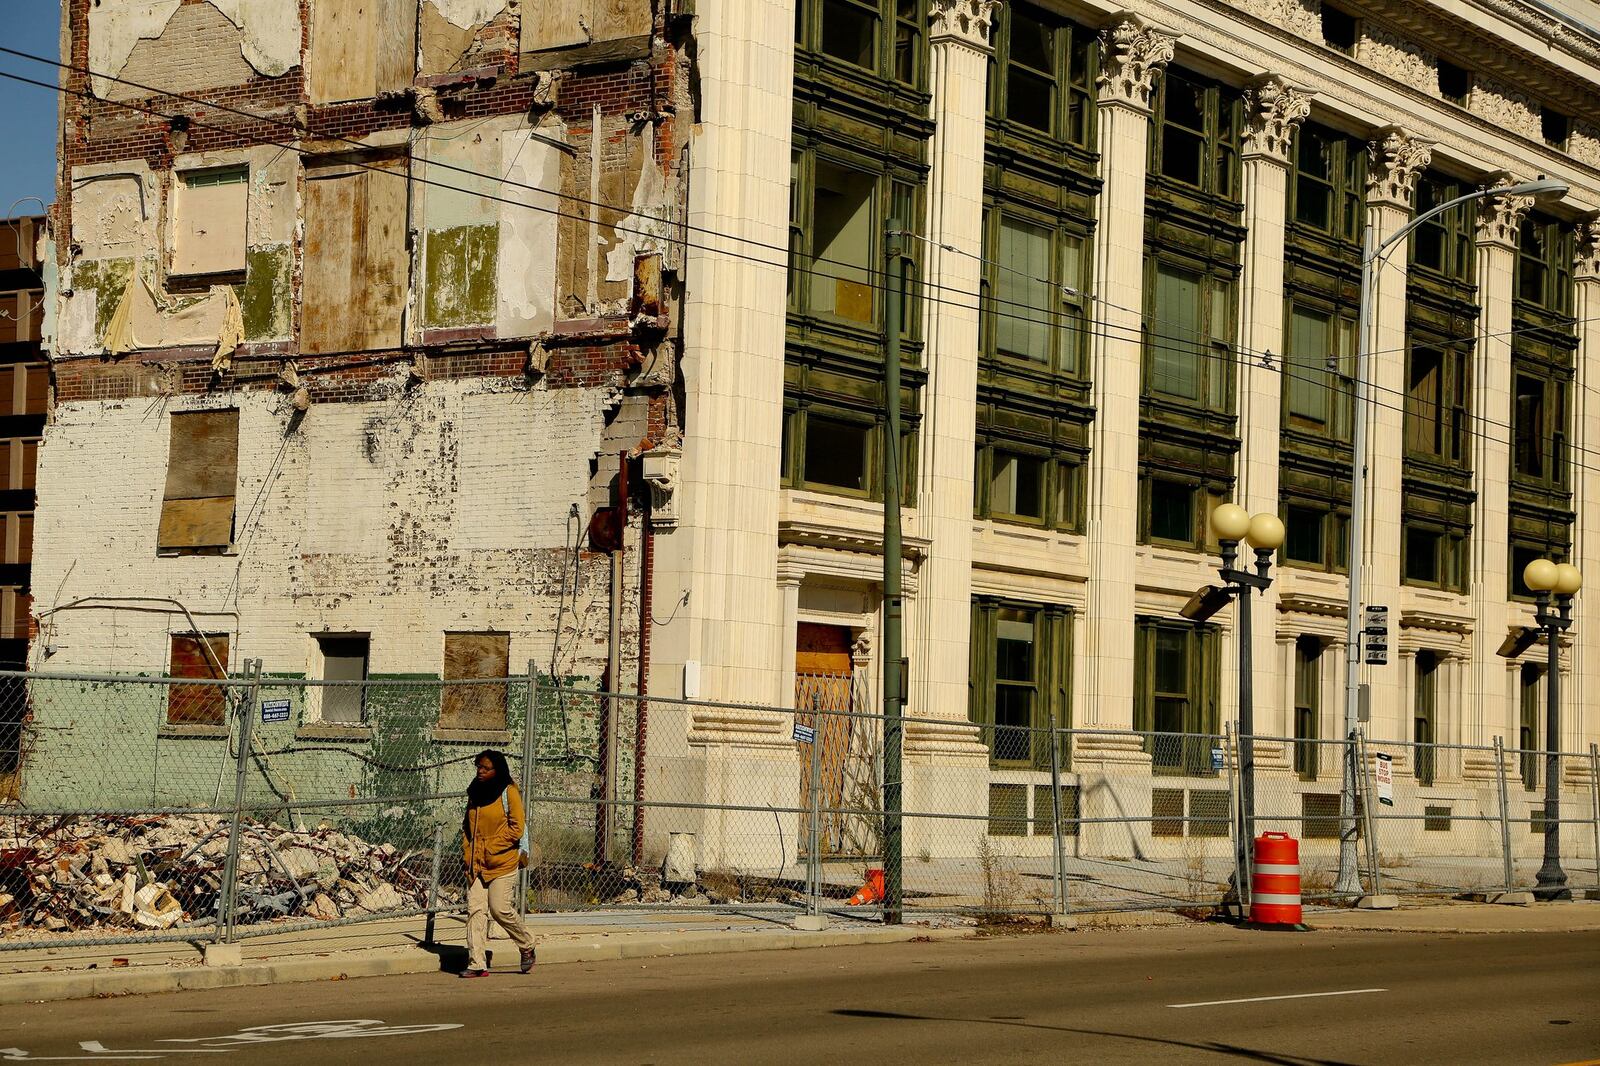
[301,157,410,354]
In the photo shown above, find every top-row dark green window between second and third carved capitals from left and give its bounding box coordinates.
[1150,66,1243,200]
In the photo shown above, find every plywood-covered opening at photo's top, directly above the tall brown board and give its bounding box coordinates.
[306,0,416,104]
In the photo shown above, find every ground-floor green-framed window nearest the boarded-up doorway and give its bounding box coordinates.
[968,597,1072,765]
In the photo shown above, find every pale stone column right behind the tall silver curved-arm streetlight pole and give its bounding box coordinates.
[1339,126,1434,738]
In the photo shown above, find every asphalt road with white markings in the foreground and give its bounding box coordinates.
[0,927,1600,1066]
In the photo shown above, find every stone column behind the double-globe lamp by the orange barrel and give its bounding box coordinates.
[1230,74,1310,755]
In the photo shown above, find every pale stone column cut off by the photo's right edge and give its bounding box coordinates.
[1562,219,1600,765]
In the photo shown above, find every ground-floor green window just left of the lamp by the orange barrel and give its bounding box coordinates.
[1133,616,1221,776]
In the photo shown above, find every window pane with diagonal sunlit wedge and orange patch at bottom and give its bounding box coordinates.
[811,160,877,322]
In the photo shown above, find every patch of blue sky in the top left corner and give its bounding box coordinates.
[0,0,61,214]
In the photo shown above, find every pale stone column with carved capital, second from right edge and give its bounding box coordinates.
[1461,176,1533,775]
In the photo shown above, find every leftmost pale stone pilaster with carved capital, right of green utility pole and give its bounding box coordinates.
[907,0,998,729]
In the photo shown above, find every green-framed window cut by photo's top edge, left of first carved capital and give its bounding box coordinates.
[795,0,928,85]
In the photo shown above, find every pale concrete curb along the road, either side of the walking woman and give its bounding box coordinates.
[0,927,971,1005]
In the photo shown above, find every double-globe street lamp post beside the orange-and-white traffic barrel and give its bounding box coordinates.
[1182,504,1283,898]
